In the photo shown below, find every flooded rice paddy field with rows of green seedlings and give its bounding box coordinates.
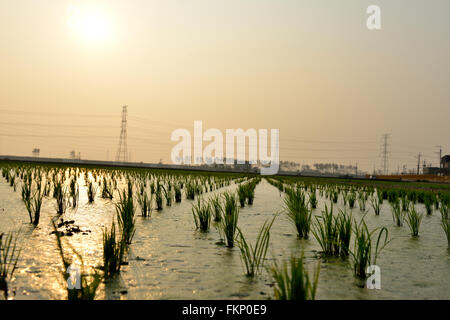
[0,163,450,300]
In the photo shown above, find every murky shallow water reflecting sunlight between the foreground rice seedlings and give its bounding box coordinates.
[0,179,450,299]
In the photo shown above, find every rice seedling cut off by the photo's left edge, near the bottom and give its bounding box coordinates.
[0,232,22,299]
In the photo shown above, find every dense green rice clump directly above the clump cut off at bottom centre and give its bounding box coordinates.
[284,189,312,239]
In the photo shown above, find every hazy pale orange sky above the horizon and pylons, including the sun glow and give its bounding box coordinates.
[0,0,450,171]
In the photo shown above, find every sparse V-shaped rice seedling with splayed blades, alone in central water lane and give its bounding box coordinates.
[237,216,276,277]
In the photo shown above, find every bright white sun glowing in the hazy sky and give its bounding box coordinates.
[67,5,112,44]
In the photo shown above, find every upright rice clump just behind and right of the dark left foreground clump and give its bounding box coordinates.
[116,190,136,244]
